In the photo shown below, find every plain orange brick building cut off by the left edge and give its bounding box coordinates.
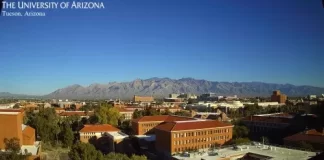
[0,109,40,159]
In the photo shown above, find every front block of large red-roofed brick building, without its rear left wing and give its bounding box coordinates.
[155,120,233,155]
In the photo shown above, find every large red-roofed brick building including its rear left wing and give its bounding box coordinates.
[132,115,233,156]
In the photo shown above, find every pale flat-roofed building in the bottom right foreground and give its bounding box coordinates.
[170,142,316,160]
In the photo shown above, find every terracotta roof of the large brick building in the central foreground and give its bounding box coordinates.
[156,120,233,131]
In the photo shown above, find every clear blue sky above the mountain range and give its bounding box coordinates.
[0,0,324,95]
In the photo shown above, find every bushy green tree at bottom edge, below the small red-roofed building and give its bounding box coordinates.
[68,143,104,160]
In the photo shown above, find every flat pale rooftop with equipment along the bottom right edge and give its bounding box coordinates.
[173,144,316,160]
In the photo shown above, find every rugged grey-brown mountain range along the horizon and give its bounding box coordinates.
[0,78,324,99]
